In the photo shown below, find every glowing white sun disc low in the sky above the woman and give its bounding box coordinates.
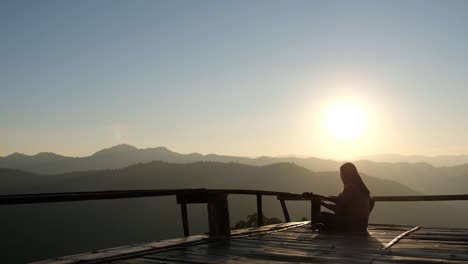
[326,103,367,140]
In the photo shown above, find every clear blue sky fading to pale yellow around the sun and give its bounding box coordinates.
[0,0,468,158]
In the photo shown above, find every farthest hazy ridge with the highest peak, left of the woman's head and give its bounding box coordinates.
[0,144,339,174]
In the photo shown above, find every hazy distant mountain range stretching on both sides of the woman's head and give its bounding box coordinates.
[0,144,468,194]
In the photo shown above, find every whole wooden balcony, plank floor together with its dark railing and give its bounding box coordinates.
[0,189,468,264]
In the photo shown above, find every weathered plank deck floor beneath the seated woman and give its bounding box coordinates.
[36,222,468,264]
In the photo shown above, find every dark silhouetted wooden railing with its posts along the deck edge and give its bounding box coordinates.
[0,189,468,237]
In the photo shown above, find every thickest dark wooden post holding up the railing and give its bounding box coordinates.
[208,192,231,237]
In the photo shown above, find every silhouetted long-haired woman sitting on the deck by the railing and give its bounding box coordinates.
[317,163,374,232]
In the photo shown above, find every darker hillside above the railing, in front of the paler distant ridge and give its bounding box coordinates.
[0,161,414,195]
